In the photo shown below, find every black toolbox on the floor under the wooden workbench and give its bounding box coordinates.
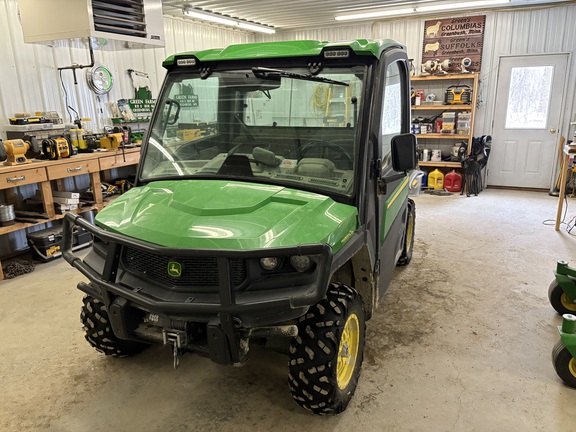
[26,226,92,262]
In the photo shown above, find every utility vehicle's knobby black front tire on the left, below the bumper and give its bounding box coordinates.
[80,296,150,357]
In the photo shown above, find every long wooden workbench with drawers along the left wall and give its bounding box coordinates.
[0,148,140,280]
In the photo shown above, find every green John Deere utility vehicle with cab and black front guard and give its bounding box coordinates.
[63,40,417,414]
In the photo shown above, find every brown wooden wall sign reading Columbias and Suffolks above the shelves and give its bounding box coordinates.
[422,15,486,73]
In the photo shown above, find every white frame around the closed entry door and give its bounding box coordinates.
[480,51,573,191]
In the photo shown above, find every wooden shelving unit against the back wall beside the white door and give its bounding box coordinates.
[411,73,478,168]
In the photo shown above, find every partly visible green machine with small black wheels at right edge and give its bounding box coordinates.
[548,261,576,387]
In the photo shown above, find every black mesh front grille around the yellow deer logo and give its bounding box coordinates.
[124,247,246,288]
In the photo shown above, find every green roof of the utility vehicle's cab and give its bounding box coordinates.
[162,39,402,69]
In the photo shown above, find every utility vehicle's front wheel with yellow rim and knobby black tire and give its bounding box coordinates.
[288,283,366,415]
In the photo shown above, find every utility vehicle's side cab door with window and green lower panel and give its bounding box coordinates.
[373,49,411,297]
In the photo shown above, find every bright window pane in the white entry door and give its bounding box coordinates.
[504,66,554,129]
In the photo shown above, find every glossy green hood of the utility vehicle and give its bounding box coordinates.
[96,180,357,253]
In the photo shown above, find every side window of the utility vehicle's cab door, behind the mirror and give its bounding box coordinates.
[380,62,402,166]
